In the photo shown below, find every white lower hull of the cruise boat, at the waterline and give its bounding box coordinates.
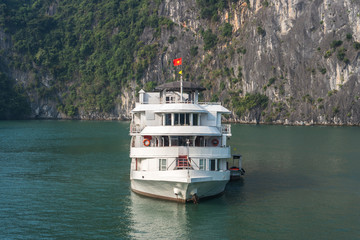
[131,170,230,202]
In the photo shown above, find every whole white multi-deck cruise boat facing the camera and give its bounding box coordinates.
[130,81,236,202]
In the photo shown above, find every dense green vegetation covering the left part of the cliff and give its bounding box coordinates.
[0,0,169,116]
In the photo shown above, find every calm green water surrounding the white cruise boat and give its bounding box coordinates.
[0,121,360,239]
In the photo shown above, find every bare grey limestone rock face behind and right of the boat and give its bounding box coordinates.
[0,0,360,125]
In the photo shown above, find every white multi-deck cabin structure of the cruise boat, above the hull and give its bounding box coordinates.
[130,82,231,171]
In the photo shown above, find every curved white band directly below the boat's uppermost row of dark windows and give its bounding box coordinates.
[141,126,221,136]
